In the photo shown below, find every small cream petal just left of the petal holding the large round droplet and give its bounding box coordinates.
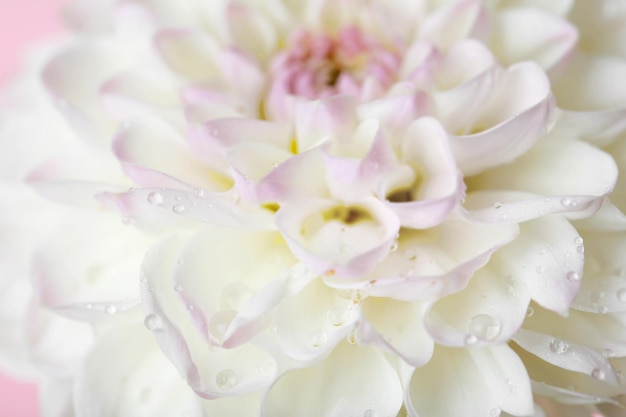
[357,297,435,367]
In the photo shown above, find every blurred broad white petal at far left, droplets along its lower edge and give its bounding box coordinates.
[33,210,152,319]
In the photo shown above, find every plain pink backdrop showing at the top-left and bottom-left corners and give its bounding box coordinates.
[0,0,66,417]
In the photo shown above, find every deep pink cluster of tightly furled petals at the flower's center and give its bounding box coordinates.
[271,27,400,99]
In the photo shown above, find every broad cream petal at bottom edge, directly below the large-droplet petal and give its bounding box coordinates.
[408,345,533,417]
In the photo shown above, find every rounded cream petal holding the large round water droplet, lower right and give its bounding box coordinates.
[425,252,530,347]
